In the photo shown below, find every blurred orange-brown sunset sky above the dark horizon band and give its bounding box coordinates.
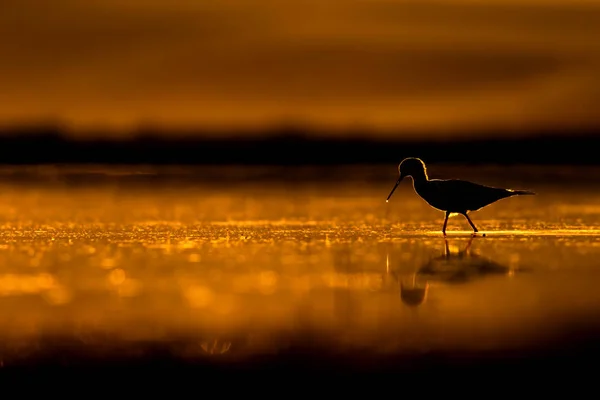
[0,0,600,138]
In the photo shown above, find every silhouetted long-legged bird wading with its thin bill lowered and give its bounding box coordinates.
[386,157,536,236]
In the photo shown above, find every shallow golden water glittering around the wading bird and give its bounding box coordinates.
[0,166,600,365]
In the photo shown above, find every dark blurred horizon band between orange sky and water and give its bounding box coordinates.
[0,129,600,165]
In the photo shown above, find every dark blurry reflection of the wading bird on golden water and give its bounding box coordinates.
[391,237,516,307]
